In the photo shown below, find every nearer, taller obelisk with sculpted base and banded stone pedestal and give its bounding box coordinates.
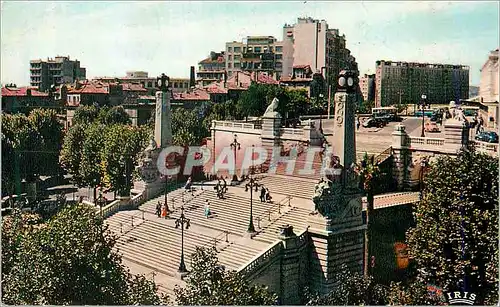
[309,70,366,294]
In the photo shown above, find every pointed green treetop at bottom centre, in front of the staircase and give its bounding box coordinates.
[174,247,277,305]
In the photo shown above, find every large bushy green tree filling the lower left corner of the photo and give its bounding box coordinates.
[2,204,168,305]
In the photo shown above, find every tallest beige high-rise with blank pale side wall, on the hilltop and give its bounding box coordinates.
[283,17,358,92]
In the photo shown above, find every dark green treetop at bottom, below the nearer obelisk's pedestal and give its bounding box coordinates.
[307,264,388,306]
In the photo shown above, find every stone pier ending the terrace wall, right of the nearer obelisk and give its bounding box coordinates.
[392,124,412,190]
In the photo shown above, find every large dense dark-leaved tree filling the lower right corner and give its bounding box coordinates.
[407,148,498,305]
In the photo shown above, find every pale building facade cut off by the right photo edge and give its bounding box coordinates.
[479,49,499,102]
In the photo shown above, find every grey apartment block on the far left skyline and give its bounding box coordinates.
[30,56,86,91]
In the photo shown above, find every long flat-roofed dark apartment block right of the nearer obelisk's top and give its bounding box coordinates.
[375,61,469,107]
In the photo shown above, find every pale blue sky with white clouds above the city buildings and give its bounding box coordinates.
[1,0,499,85]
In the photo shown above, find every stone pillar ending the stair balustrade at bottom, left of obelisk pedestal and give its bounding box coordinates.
[279,225,301,305]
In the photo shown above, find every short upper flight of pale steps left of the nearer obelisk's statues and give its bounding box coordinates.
[259,175,317,201]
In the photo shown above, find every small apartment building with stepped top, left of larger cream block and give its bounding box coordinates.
[196,51,226,86]
